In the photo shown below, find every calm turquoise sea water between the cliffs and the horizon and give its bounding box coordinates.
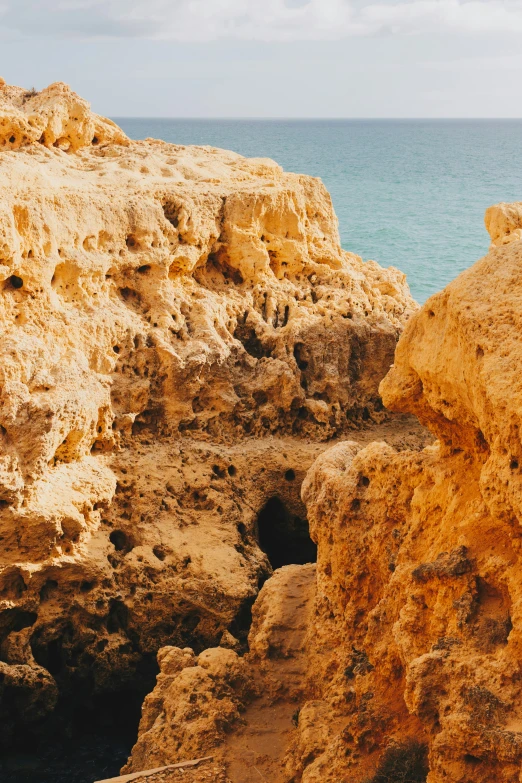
[116,118,522,302]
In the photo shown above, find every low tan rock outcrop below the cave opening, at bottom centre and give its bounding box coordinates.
[122,563,316,783]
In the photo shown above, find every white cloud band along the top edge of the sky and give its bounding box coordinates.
[0,0,522,42]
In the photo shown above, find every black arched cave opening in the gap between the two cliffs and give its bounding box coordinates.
[257,497,317,570]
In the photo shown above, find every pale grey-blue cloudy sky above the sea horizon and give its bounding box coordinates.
[0,0,522,117]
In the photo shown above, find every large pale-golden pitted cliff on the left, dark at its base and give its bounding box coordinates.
[0,79,415,742]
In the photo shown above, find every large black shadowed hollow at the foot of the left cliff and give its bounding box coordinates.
[21,608,158,783]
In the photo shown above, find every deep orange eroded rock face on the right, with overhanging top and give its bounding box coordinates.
[293,216,522,783]
